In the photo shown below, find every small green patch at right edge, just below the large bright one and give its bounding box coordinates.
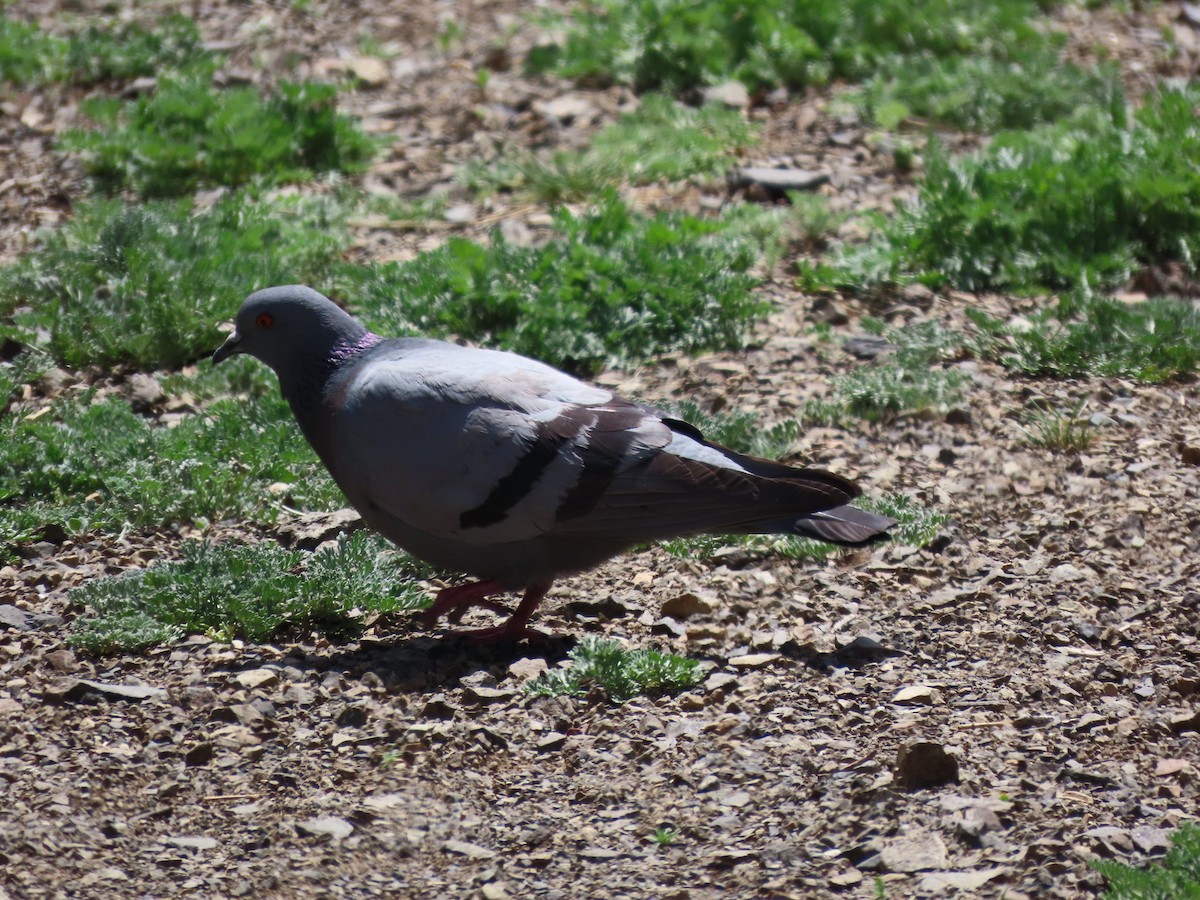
[970,290,1200,383]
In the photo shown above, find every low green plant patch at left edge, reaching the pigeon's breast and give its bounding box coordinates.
[0,394,344,542]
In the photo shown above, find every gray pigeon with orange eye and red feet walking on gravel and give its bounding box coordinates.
[212,284,895,642]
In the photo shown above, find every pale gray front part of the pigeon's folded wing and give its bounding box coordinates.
[319,343,671,544]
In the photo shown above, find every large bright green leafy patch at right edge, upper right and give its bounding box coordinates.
[805,88,1200,293]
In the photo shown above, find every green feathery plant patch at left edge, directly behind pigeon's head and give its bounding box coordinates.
[0,193,346,370]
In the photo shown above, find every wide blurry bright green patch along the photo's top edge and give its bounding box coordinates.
[530,0,1049,91]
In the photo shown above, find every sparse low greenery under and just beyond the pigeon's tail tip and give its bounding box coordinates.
[661,493,947,562]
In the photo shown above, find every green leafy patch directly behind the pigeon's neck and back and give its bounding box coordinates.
[343,194,767,373]
